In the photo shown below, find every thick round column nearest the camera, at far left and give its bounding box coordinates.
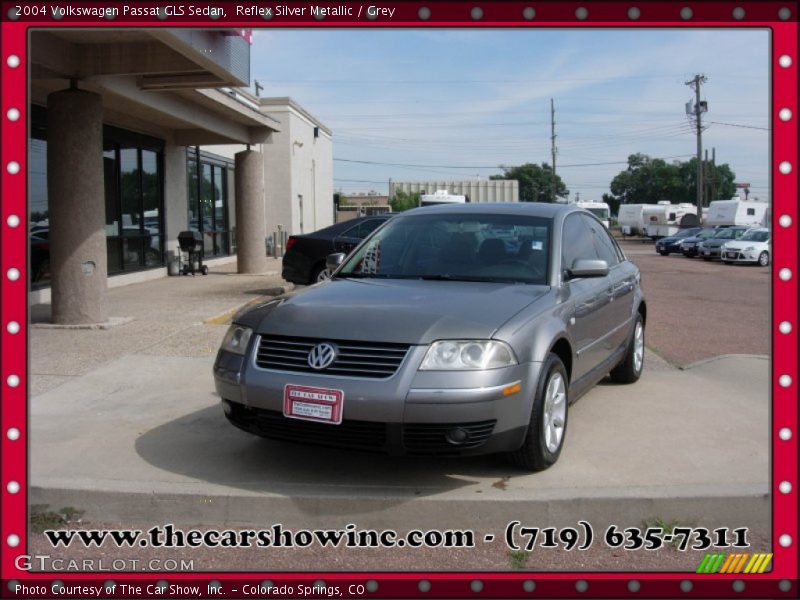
[47,89,108,325]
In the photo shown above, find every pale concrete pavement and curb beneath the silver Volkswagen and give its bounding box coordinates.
[29,264,770,531]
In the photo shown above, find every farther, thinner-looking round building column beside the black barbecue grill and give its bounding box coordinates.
[234,150,267,273]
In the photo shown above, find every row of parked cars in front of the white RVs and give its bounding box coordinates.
[656,227,771,267]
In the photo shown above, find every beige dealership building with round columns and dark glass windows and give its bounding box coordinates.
[27,28,334,324]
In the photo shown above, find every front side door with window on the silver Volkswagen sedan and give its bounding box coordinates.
[561,213,611,381]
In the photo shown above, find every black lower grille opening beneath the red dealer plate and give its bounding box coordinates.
[228,402,386,451]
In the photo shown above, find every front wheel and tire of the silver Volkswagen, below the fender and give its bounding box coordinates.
[508,354,569,471]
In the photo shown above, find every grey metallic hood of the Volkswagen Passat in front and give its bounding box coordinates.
[236,279,550,344]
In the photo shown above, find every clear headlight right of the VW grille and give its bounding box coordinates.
[419,340,518,371]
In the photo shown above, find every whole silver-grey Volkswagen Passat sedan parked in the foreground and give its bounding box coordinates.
[214,203,646,470]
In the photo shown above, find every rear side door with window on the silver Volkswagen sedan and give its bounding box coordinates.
[581,215,636,354]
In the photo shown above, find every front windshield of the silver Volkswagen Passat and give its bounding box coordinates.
[336,214,552,285]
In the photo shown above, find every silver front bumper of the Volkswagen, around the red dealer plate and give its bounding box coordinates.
[214,344,541,455]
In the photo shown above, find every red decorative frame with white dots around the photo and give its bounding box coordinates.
[0,0,800,598]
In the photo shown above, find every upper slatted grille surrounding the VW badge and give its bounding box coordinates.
[256,336,410,379]
